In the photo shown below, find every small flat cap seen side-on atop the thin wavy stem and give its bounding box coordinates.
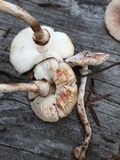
[65,51,109,66]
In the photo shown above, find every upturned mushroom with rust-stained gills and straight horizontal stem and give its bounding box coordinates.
[0,58,77,122]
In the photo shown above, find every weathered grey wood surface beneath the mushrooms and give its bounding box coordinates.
[0,0,120,160]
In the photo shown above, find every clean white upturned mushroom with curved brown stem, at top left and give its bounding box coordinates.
[0,0,74,74]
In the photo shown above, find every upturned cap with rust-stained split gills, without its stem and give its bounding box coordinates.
[31,58,77,122]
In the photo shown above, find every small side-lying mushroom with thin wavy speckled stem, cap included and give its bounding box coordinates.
[65,51,109,160]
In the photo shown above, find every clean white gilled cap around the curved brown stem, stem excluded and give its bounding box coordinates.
[10,26,74,74]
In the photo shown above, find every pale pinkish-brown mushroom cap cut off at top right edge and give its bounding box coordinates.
[105,0,120,41]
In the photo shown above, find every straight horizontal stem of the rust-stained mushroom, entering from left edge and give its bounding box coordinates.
[0,80,51,97]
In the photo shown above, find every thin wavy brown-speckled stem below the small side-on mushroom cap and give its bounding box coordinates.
[75,65,92,160]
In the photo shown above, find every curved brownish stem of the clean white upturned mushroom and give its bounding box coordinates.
[0,0,50,45]
